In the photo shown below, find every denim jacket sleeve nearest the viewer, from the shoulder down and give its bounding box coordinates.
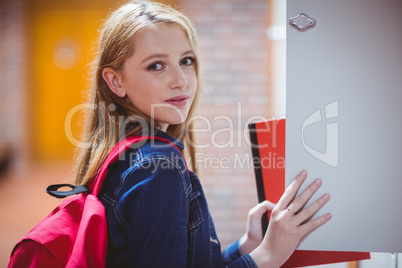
[119,159,189,268]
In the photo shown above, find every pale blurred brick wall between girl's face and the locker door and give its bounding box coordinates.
[180,0,269,247]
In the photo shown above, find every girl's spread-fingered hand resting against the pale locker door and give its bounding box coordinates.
[250,171,331,267]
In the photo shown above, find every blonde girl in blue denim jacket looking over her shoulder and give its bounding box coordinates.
[76,1,331,267]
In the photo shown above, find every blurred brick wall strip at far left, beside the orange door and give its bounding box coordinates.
[0,0,28,170]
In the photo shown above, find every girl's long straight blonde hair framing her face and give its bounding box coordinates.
[75,0,201,185]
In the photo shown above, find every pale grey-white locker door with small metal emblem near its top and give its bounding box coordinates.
[286,0,402,252]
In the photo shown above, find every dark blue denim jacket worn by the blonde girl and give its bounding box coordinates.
[99,131,257,268]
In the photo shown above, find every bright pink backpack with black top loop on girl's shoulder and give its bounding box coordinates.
[8,136,180,268]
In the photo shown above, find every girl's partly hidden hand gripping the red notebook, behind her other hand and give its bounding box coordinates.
[240,200,275,255]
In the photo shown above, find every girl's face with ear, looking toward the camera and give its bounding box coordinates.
[107,24,197,131]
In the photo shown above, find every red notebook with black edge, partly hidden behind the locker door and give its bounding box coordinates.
[249,119,370,268]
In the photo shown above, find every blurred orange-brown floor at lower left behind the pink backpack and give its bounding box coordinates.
[0,163,72,267]
